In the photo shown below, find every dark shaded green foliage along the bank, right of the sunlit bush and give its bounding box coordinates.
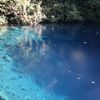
[44,0,100,22]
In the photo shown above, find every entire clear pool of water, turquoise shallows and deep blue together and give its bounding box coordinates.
[0,24,100,100]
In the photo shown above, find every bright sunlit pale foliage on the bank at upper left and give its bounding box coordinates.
[0,0,44,25]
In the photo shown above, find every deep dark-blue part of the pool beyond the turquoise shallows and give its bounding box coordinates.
[1,24,100,100]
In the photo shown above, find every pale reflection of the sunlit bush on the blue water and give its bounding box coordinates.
[8,26,49,73]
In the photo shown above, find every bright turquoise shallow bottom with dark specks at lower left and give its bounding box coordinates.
[0,50,64,100]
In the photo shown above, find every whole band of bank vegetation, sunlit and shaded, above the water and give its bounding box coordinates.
[0,0,100,25]
